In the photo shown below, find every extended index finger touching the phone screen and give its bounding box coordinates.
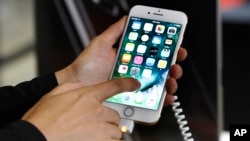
[93,78,141,102]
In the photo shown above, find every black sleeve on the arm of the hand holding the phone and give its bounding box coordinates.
[0,74,57,127]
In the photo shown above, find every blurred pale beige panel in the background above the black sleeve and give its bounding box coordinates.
[0,0,37,86]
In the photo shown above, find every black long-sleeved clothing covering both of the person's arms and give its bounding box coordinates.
[0,74,58,141]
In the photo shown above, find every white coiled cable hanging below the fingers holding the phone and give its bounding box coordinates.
[172,96,194,141]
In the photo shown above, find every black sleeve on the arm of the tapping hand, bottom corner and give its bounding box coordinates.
[0,120,46,141]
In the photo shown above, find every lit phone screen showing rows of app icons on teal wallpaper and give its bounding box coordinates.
[107,17,182,110]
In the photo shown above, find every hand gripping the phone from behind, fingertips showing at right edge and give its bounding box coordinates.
[56,16,187,105]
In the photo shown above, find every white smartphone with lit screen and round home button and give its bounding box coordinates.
[103,5,187,124]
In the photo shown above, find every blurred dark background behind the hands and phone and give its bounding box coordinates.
[0,0,250,141]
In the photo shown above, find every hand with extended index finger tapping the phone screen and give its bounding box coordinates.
[22,78,140,141]
